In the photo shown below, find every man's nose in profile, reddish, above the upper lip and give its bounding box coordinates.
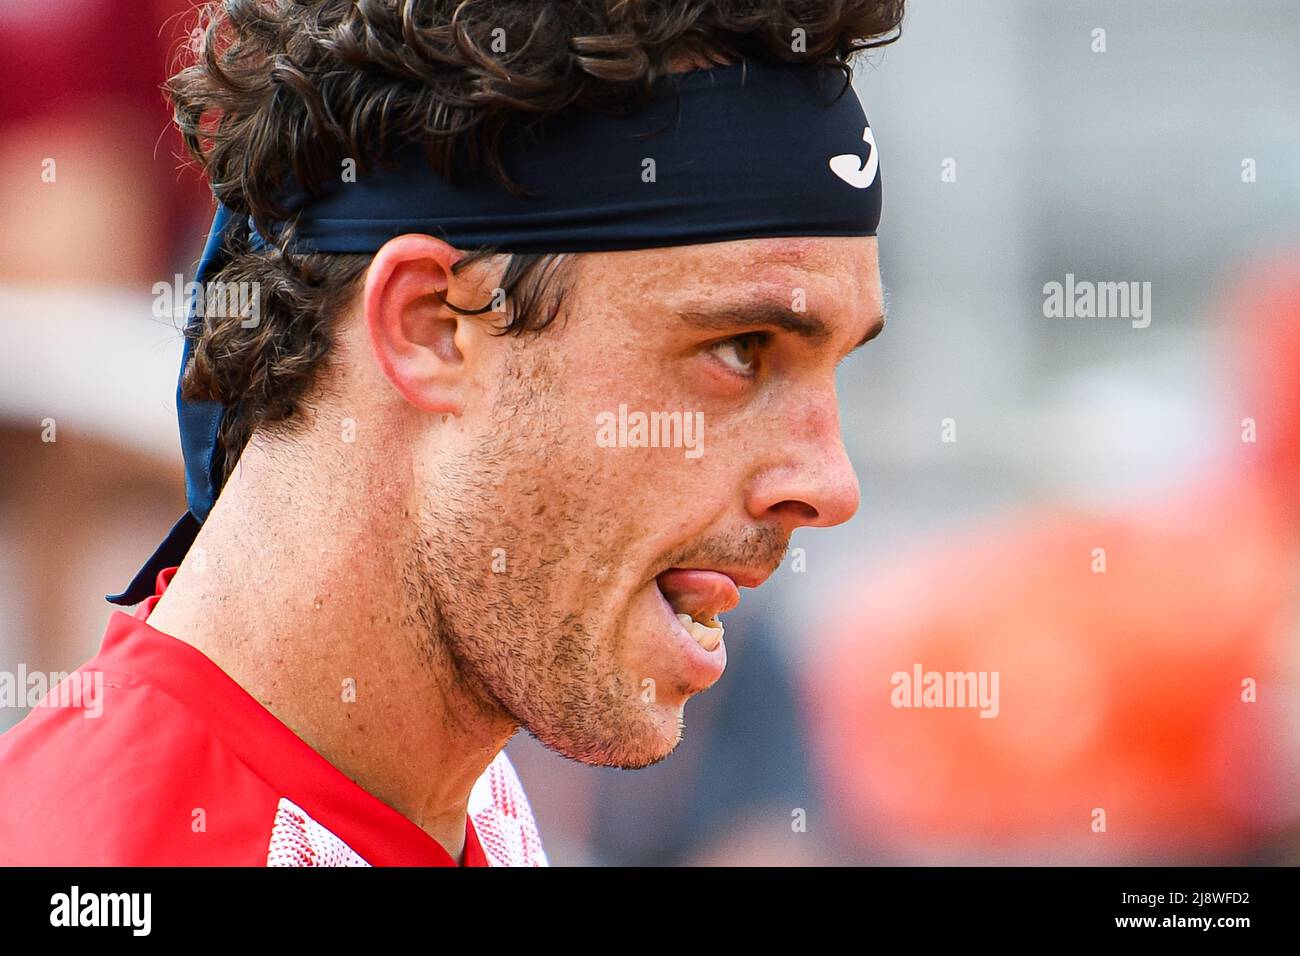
[745,397,861,535]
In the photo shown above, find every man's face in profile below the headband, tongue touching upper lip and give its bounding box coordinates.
[412,238,883,767]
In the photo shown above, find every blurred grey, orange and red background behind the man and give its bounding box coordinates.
[0,0,1300,865]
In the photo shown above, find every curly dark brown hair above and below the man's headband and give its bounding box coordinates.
[164,0,905,481]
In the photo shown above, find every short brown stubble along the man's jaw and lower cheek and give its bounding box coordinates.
[402,341,681,769]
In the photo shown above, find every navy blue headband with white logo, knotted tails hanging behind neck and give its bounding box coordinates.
[108,55,880,605]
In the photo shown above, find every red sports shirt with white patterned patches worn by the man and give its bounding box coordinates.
[0,568,546,866]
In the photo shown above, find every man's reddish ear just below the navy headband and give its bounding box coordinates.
[361,234,481,415]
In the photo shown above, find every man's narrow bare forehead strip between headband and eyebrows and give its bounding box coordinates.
[579,235,881,315]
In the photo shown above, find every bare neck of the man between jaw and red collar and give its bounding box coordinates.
[150,442,517,860]
